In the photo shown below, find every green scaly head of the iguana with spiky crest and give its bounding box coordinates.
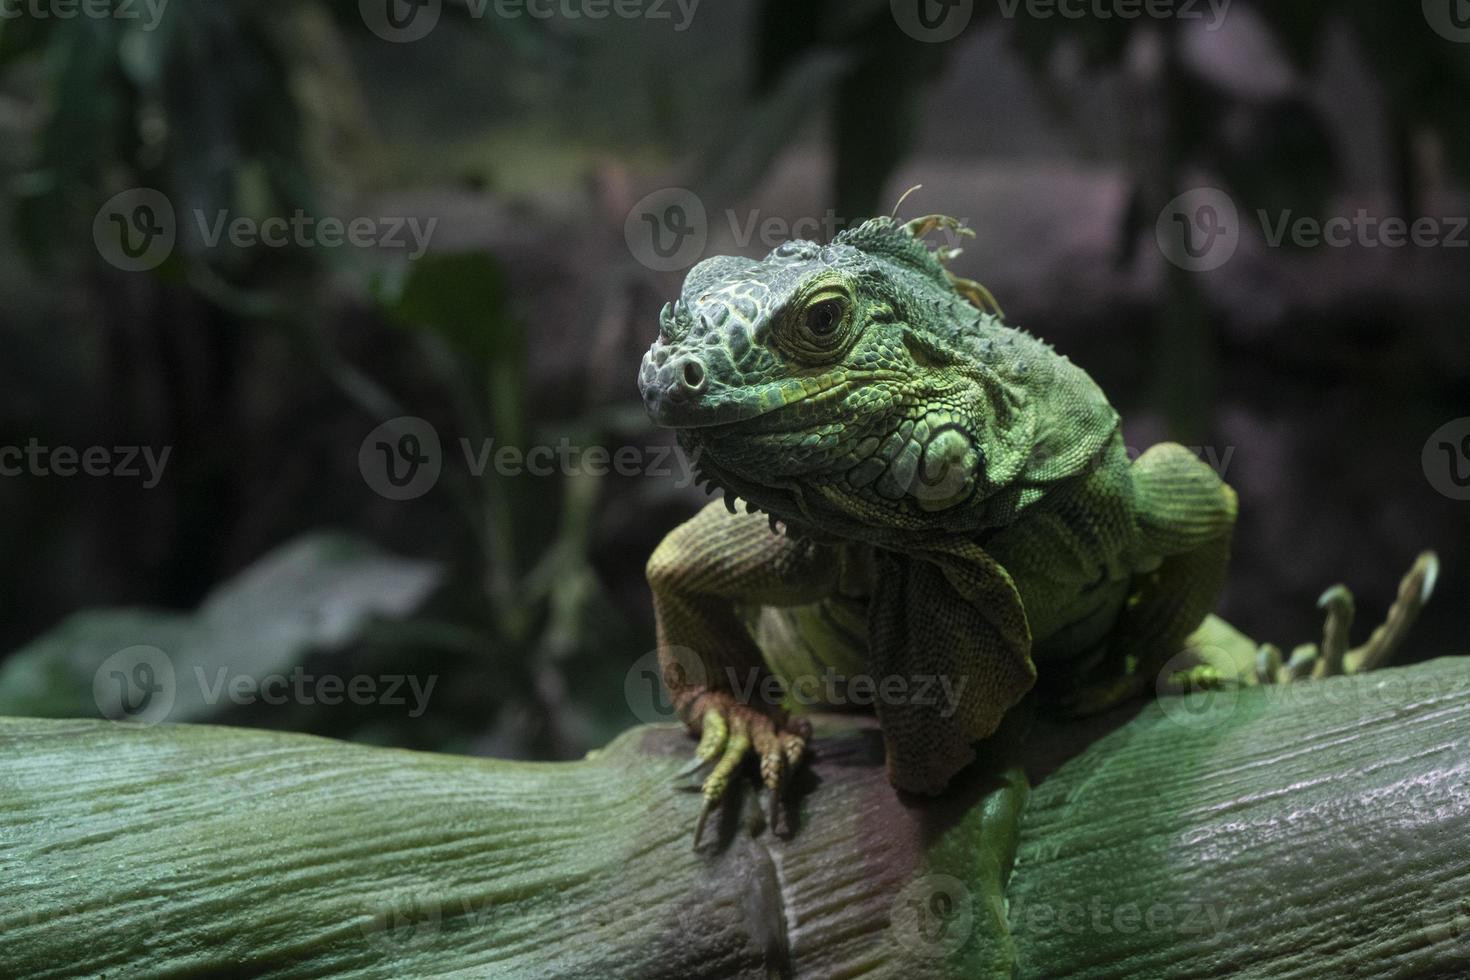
[638,216,1105,536]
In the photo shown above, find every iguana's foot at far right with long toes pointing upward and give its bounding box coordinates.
[1255,551,1439,683]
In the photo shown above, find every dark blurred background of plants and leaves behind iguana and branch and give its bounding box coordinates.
[0,0,1470,758]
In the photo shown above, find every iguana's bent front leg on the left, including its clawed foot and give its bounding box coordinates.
[648,502,839,846]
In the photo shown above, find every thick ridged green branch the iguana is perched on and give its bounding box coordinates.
[0,660,1470,980]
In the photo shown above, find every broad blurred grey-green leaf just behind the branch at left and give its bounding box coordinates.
[0,533,442,721]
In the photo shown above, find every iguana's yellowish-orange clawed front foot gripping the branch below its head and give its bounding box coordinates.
[685,691,811,848]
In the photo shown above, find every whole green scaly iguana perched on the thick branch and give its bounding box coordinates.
[638,216,1436,843]
